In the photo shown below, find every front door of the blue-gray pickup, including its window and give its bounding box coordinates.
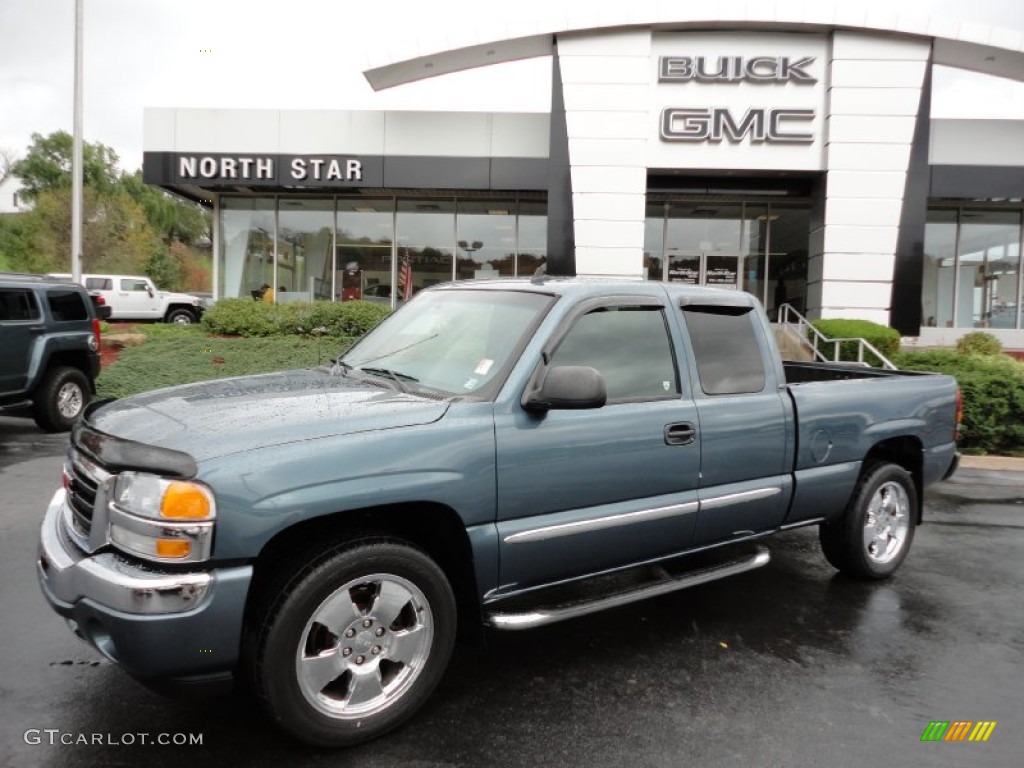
[496,296,700,591]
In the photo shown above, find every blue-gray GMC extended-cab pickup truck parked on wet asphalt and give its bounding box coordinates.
[38,278,959,745]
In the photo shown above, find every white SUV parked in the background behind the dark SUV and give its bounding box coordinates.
[54,274,206,326]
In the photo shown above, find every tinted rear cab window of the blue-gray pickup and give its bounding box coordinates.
[683,305,766,395]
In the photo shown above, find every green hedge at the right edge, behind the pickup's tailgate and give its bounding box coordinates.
[893,349,1024,455]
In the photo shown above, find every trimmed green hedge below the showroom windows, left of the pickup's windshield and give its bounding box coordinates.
[203,299,390,336]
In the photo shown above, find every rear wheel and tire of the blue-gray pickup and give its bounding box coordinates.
[818,463,918,580]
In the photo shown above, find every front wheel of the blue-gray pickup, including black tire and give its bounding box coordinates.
[253,539,456,746]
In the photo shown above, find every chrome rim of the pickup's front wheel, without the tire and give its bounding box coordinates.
[295,573,434,719]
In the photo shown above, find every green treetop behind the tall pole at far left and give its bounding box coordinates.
[12,131,118,200]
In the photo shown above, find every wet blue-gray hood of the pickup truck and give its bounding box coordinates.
[86,369,449,462]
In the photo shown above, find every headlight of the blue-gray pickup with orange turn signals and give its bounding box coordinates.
[109,472,217,562]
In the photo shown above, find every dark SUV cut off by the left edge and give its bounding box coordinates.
[0,272,99,432]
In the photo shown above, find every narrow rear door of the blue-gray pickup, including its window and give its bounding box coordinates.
[682,304,793,546]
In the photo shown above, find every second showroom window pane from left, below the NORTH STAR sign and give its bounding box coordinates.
[276,198,334,303]
